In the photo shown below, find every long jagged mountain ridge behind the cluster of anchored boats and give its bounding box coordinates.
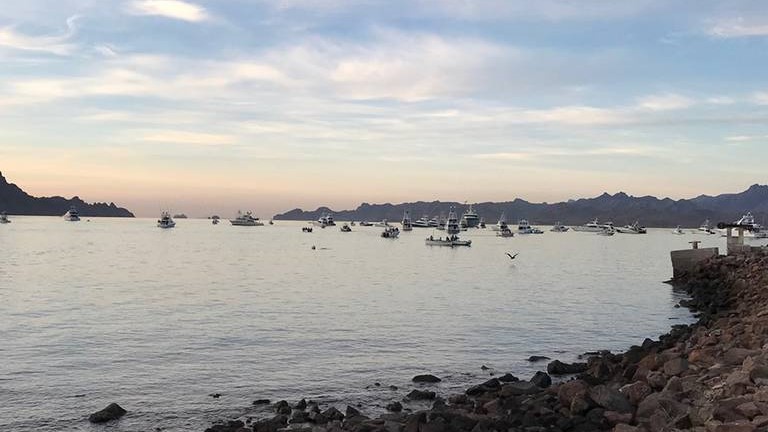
[274,184,768,227]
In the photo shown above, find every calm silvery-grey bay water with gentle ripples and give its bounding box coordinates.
[0,217,744,431]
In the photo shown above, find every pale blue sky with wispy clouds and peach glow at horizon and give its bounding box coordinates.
[0,0,768,218]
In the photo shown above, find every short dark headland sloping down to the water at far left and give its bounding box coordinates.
[0,173,133,217]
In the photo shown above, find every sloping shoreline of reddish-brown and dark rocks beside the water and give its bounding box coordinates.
[206,252,768,432]
